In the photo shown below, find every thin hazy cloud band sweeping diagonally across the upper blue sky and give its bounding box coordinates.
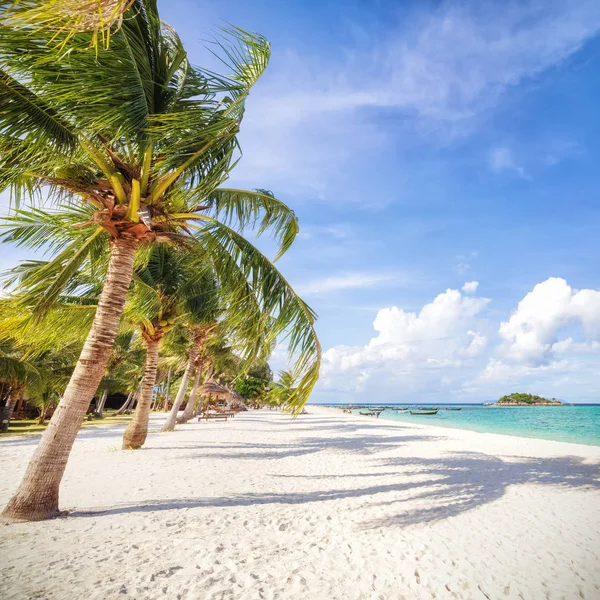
[235,0,600,190]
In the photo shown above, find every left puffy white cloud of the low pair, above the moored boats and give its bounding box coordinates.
[321,289,489,397]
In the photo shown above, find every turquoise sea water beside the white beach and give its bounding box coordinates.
[330,404,600,446]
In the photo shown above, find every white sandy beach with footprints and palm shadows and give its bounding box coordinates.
[0,407,600,600]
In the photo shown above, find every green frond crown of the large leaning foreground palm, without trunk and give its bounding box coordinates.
[0,0,320,406]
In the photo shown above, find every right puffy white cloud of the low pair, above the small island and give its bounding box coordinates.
[499,277,600,366]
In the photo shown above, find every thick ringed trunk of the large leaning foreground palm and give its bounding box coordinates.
[2,234,138,521]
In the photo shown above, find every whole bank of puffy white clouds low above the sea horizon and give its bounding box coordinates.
[319,277,600,402]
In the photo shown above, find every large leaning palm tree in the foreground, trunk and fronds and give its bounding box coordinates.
[0,0,319,520]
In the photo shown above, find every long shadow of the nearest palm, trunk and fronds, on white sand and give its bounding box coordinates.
[72,452,600,529]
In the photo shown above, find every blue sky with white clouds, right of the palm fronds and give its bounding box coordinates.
[0,0,600,402]
